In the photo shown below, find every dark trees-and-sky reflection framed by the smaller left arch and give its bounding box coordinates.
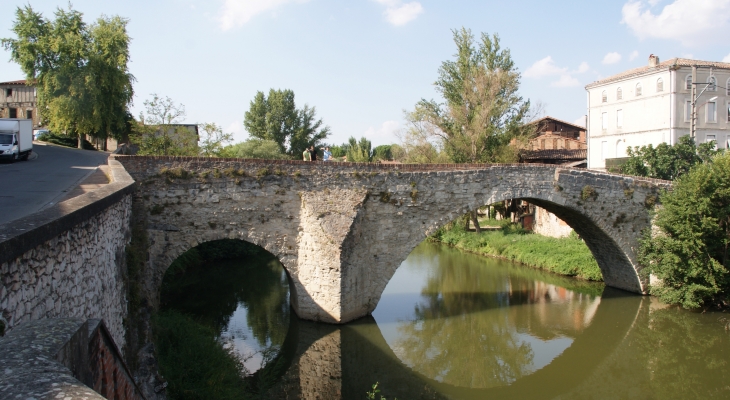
[160,240,290,372]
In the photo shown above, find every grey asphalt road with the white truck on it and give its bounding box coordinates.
[0,142,109,224]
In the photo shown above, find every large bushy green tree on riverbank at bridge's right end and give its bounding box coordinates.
[639,154,730,308]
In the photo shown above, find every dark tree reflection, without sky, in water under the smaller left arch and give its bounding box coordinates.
[160,242,289,347]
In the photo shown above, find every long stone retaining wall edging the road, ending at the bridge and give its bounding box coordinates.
[0,162,133,348]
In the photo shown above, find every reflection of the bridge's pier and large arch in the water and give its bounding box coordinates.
[268,288,642,399]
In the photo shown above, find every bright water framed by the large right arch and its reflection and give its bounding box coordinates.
[373,243,602,388]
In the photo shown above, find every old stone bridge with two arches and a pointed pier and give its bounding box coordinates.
[116,156,670,323]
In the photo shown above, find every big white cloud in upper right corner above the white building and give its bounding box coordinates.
[621,0,730,46]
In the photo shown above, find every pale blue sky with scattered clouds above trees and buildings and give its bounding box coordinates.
[0,0,730,145]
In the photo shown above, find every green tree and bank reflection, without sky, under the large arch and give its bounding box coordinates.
[395,242,600,388]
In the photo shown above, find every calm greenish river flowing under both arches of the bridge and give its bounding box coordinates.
[158,242,730,400]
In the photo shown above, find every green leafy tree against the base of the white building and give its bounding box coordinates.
[620,136,721,180]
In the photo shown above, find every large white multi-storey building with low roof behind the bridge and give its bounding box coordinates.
[586,55,730,169]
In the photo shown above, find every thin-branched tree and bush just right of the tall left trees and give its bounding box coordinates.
[131,93,199,156]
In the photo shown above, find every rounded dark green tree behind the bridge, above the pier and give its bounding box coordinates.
[243,89,330,157]
